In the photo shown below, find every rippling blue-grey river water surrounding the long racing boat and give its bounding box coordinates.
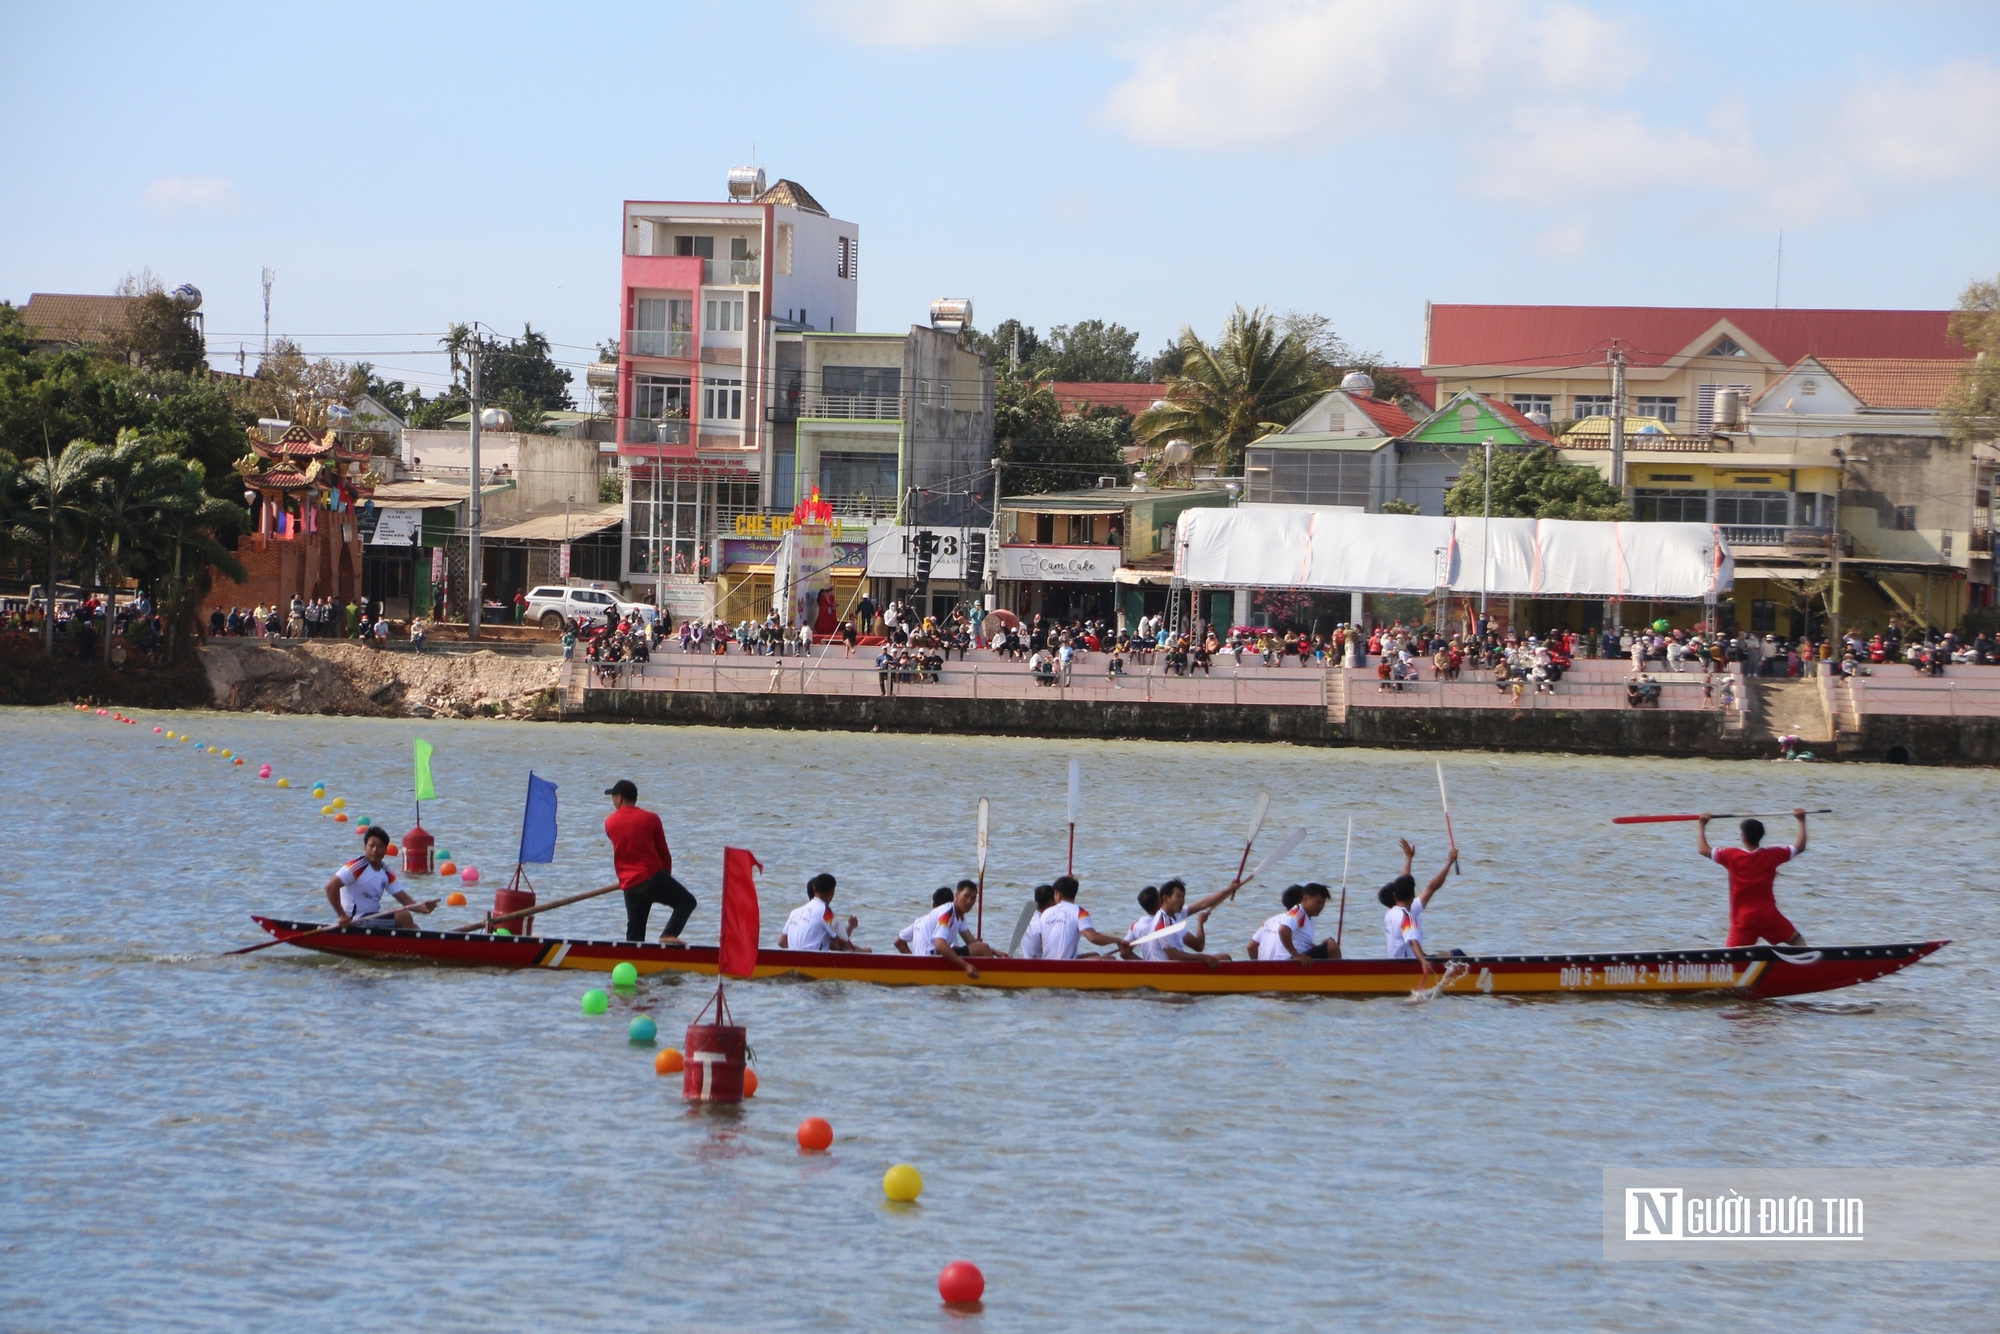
[0,710,2000,1334]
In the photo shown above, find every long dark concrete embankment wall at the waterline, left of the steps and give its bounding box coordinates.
[582,690,1784,758]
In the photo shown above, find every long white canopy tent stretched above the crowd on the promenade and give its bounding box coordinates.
[1174,506,1736,602]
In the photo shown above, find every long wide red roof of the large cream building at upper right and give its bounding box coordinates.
[1424,306,1968,370]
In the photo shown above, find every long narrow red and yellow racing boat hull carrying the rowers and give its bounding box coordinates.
[252,916,1950,998]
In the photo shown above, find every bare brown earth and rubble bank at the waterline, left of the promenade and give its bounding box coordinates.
[202,640,562,718]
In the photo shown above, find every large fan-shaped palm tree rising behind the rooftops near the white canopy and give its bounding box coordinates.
[1132,306,1326,476]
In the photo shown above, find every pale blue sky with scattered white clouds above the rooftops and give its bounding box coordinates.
[0,0,2000,396]
